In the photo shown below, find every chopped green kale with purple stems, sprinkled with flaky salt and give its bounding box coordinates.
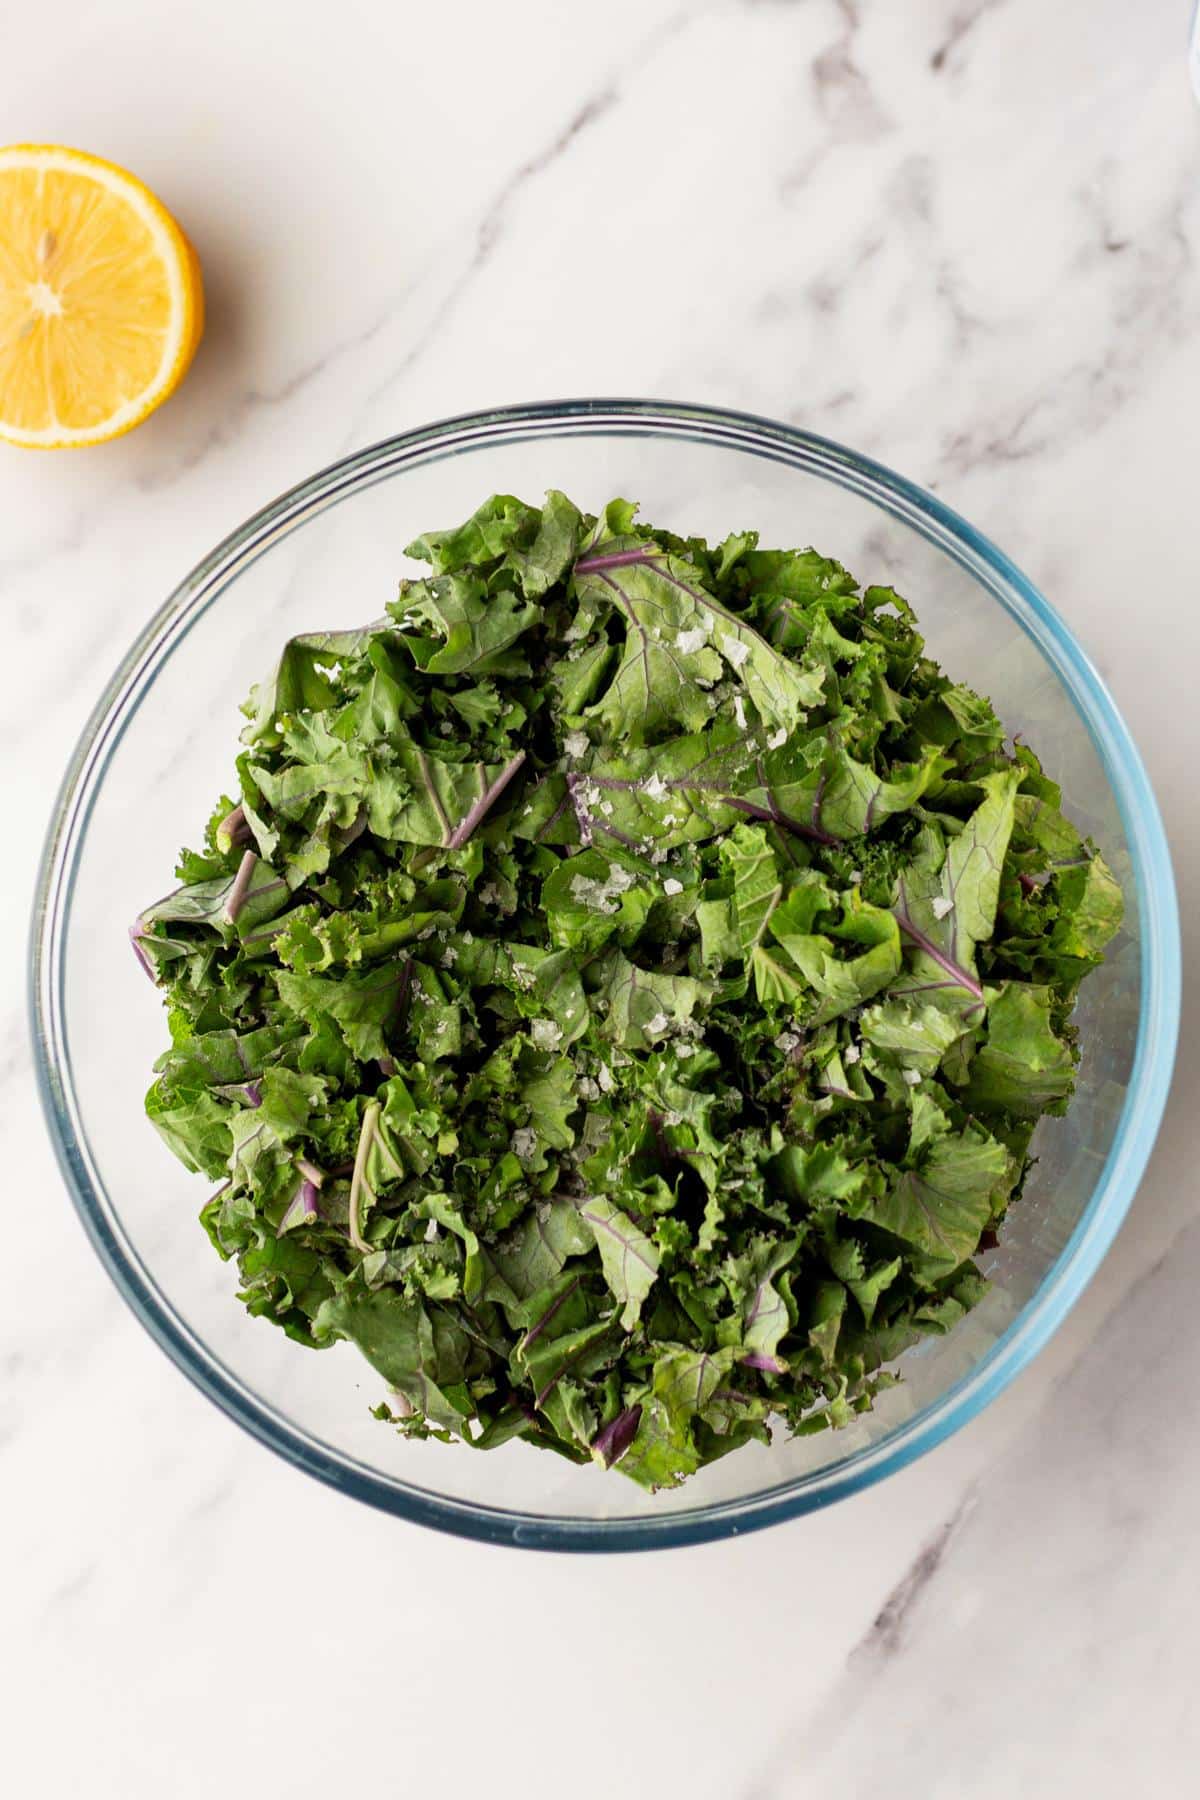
[131,493,1121,1487]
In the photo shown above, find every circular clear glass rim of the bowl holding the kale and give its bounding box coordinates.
[29,398,1180,1552]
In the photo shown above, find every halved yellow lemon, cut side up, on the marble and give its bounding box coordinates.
[0,144,203,450]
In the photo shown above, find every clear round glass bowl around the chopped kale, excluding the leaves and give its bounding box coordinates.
[32,400,1180,1550]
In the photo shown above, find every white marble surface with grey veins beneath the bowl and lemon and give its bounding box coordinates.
[0,0,1200,1800]
